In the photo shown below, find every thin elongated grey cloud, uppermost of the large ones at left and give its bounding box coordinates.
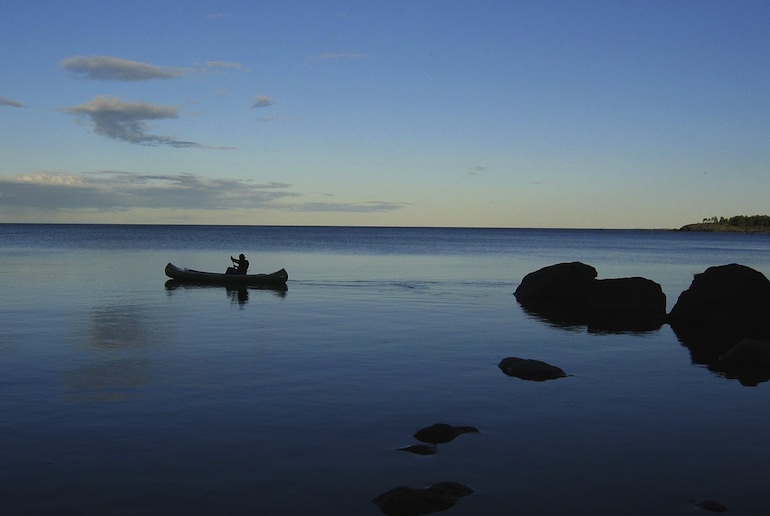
[59,56,188,81]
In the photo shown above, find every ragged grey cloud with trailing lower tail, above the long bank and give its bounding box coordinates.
[64,95,219,148]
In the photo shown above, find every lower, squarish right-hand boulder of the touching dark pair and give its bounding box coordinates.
[588,277,666,331]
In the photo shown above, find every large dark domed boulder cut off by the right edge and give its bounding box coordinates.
[668,263,770,328]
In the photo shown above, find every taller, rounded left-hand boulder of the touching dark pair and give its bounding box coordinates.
[514,262,597,301]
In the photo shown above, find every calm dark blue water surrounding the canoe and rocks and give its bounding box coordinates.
[0,225,770,515]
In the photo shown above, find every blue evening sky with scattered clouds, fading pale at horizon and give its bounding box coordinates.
[0,0,770,228]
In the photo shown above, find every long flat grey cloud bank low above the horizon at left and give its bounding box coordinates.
[0,171,298,211]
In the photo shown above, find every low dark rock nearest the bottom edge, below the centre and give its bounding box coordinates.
[372,482,473,516]
